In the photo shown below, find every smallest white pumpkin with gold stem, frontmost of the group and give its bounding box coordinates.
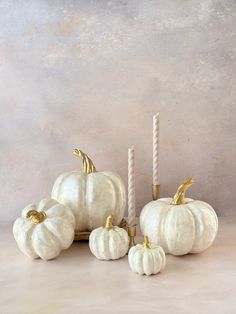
[128,236,166,276]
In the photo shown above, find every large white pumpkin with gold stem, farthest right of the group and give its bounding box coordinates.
[140,179,218,255]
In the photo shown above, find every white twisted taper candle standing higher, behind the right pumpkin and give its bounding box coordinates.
[152,112,160,185]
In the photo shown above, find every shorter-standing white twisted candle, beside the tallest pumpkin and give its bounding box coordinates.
[128,146,136,226]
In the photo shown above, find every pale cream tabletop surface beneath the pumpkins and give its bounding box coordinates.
[0,218,236,314]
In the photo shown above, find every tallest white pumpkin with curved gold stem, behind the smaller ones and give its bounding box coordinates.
[51,150,126,232]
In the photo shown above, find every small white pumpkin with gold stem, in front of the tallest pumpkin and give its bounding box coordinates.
[89,215,129,260]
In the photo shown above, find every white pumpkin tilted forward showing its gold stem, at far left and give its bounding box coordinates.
[13,199,75,260]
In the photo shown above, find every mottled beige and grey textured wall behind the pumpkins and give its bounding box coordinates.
[0,0,236,221]
